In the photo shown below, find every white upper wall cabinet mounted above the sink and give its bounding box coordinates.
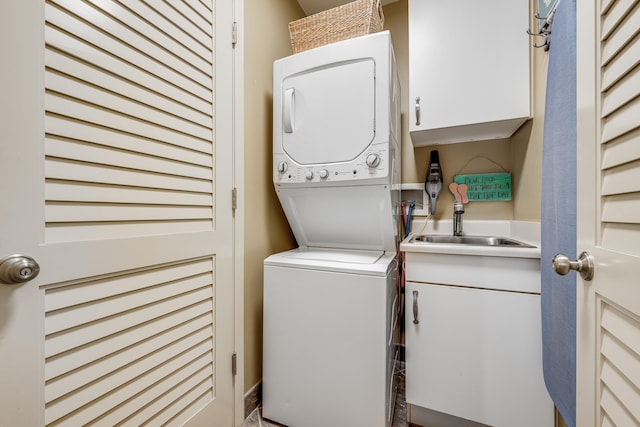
[408,0,531,146]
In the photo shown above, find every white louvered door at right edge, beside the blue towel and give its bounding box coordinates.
[576,0,640,427]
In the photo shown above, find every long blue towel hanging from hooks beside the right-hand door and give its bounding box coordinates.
[540,0,576,427]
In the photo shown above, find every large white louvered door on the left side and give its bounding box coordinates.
[0,0,234,427]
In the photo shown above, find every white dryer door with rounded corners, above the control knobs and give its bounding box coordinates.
[280,58,376,165]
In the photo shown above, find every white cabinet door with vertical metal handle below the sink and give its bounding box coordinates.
[406,282,553,427]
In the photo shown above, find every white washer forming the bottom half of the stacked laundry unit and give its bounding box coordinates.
[262,249,397,427]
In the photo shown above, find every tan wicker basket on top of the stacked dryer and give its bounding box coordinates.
[289,0,384,53]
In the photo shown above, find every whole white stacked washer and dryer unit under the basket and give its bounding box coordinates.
[263,31,400,427]
